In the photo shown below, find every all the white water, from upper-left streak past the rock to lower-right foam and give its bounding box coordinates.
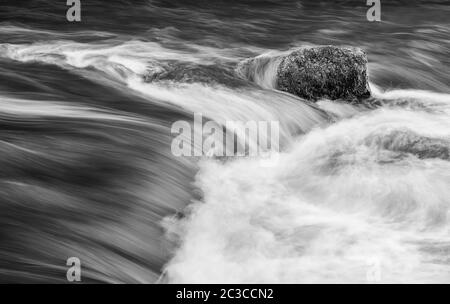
[0,35,450,283]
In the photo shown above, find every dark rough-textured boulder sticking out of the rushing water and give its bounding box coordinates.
[276,46,370,100]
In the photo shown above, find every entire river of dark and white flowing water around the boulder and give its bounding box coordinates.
[0,0,450,283]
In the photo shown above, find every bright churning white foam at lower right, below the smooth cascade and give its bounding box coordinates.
[166,87,450,283]
